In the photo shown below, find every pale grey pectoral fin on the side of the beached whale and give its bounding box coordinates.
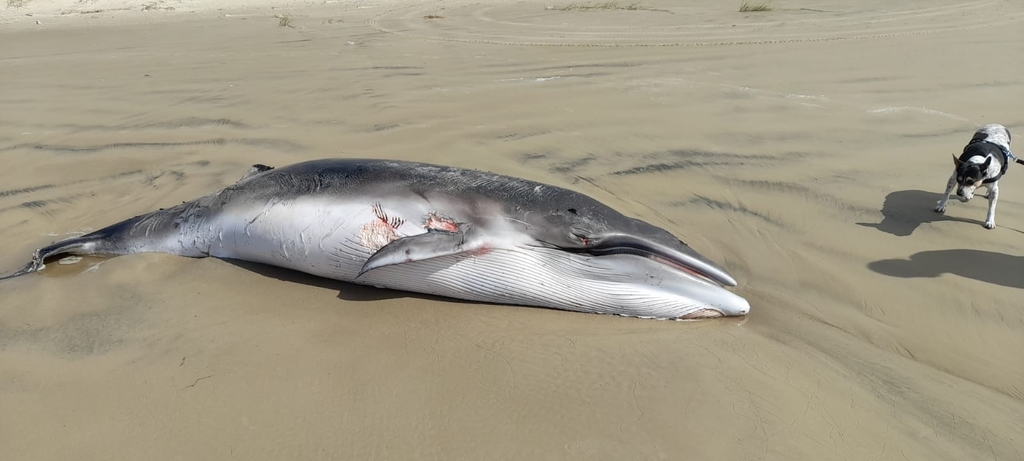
[355,227,482,278]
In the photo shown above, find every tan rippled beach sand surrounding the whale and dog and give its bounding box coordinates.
[0,0,1024,460]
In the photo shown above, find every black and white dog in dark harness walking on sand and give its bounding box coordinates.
[935,123,1024,228]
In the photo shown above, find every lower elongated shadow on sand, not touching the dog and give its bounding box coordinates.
[867,249,1024,288]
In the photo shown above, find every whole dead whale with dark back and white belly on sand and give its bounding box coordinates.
[0,159,750,320]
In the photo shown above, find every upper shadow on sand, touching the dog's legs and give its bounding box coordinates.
[857,191,987,237]
